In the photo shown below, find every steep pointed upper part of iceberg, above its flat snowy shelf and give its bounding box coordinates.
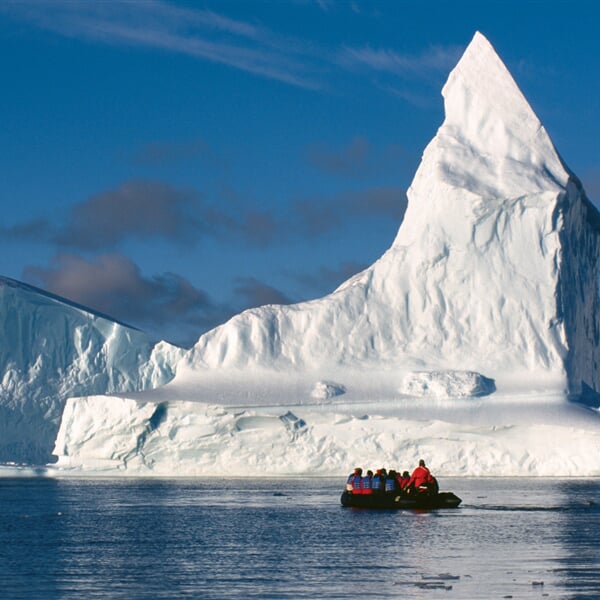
[178,34,600,394]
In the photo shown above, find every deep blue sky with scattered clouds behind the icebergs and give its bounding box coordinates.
[0,0,600,346]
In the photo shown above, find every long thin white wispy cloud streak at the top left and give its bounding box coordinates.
[0,0,320,89]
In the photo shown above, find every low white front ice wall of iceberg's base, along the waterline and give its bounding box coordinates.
[48,397,600,477]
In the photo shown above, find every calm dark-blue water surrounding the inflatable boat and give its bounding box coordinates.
[0,479,600,600]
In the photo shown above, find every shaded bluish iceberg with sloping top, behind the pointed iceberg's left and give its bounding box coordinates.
[0,277,183,464]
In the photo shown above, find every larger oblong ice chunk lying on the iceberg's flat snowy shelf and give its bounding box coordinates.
[400,371,496,399]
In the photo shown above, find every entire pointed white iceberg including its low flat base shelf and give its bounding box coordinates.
[50,33,600,475]
